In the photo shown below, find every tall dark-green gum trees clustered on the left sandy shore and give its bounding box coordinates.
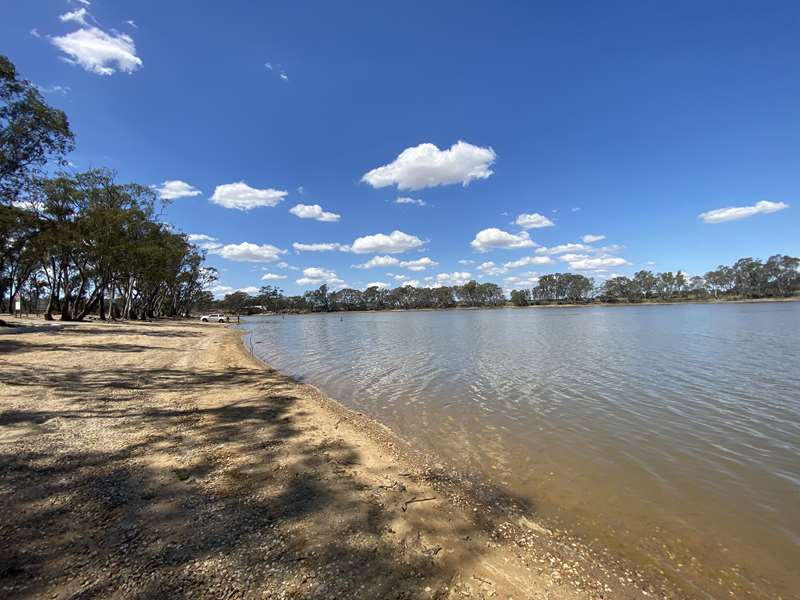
[0,55,216,320]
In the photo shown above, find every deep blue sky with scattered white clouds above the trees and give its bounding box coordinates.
[0,0,800,293]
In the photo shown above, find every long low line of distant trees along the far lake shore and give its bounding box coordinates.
[212,255,800,314]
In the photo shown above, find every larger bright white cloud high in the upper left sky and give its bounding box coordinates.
[50,27,144,75]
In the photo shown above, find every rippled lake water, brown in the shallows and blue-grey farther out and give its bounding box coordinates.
[243,303,800,598]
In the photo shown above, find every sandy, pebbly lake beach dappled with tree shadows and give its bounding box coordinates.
[0,319,685,599]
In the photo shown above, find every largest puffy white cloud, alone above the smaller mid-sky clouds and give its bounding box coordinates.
[361,141,497,190]
